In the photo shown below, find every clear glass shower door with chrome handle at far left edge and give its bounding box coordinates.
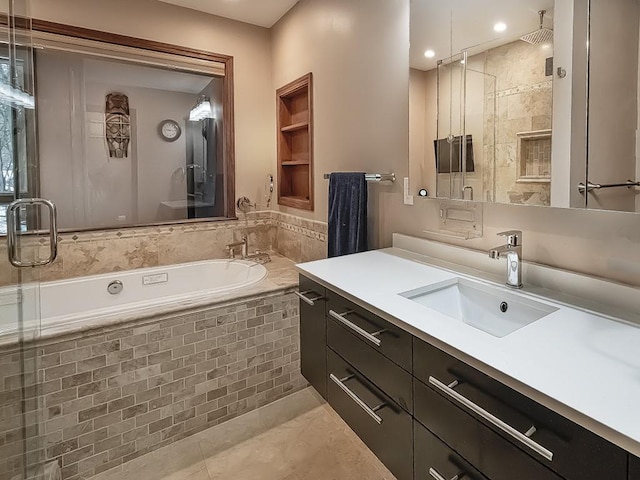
[0,0,55,480]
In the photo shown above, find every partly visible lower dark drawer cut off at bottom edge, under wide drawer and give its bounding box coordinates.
[413,422,488,480]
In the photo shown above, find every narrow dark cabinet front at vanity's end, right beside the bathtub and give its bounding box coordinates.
[298,275,327,399]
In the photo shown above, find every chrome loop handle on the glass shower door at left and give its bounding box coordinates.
[7,198,58,268]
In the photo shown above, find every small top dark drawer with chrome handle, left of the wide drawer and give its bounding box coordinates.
[327,291,413,373]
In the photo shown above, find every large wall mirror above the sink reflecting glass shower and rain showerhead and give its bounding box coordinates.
[409,0,640,212]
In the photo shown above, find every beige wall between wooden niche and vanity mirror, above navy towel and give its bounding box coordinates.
[273,0,409,240]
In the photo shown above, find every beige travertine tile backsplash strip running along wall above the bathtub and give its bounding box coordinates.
[0,211,327,286]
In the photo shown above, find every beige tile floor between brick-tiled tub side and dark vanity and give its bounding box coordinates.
[91,389,395,480]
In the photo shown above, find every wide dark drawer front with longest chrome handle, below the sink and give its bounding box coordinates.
[414,338,627,480]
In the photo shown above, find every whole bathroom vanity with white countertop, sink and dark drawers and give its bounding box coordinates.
[298,236,640,480]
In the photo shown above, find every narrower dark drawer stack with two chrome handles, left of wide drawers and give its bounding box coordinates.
[327,291,413,480]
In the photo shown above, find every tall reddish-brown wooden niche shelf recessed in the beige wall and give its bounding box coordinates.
[276,73,313,210]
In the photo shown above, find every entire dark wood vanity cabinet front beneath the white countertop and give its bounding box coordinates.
[300,276,640,480]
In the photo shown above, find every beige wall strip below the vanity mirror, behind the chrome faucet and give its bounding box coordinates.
[380,195,640,287]
